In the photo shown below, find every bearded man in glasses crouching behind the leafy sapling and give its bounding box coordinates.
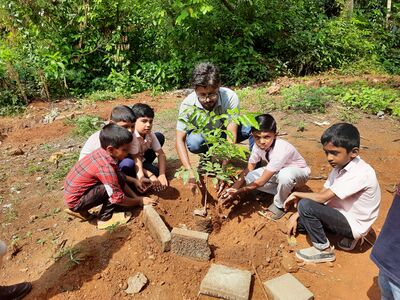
[176,63,253,193]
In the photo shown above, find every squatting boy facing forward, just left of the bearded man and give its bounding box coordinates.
[132,103,168,191]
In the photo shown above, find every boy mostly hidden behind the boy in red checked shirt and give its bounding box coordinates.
[79,105,149,193]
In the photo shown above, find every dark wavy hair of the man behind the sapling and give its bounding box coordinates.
[192,62,221,88]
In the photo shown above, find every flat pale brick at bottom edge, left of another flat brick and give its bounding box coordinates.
[199,264,251,300]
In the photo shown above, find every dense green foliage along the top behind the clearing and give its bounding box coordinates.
[0,0,400,109]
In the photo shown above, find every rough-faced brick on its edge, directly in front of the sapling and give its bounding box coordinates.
[171,228,211,261]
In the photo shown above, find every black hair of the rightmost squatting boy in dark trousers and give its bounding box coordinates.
[321,123,360,153]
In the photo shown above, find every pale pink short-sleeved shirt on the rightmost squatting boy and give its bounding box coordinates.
[324,156,381,238]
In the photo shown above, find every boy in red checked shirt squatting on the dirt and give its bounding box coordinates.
[64,124,154,229]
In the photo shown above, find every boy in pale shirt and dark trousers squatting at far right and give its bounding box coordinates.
[284,123,381,263]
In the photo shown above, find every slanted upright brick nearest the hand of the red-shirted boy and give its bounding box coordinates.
[143,205,171,252]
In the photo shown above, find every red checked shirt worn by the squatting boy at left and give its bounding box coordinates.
[64,148,125,208]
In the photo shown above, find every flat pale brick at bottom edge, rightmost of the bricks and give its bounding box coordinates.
[264,273,314,300]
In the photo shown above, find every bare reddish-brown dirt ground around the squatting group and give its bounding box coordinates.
[0,78,400,299]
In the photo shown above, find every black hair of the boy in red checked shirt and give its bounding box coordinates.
[100,123,133,149]
